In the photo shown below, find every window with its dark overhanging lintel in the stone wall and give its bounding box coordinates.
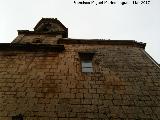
[79,52,95,73]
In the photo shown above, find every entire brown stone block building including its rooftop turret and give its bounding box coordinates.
[0,18,160,120]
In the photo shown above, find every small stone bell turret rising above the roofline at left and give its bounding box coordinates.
[12,18,68,44]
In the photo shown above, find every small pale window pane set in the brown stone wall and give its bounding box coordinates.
[81,60,93,72]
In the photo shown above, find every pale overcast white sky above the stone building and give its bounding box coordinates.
[0,0,160,63]
